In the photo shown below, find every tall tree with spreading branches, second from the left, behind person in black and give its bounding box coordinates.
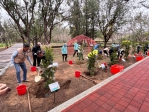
[38,0,64,43]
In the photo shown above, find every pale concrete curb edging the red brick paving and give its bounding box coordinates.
[48,56,149,112]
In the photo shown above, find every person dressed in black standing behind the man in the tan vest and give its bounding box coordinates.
[32,42,41,67]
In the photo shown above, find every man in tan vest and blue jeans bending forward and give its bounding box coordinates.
[10,43,32,84]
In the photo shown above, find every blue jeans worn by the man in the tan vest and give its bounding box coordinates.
[14,63,27,83]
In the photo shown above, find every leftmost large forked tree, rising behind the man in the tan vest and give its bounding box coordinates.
[0,0,37,43]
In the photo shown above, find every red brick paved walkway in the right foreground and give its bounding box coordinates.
[57,58,149,112]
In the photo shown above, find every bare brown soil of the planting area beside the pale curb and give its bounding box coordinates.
[0,48,139,112]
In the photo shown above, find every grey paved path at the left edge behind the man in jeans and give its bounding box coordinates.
[0,43,23,75]
